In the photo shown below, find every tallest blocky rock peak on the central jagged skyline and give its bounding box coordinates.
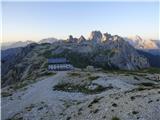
[89,31,102,43]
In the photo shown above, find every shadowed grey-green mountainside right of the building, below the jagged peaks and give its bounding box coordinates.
[53,35,149,70]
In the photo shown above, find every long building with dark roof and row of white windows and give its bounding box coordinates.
[48,58,73,71]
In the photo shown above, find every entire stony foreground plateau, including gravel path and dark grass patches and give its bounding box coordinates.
[2,70,160,120]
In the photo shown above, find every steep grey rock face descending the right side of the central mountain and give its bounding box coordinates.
[102,36,150,70]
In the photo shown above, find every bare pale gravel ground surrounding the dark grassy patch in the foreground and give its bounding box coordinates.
[2,72,160,120]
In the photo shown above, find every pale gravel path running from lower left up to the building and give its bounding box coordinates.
[2,72,82,120]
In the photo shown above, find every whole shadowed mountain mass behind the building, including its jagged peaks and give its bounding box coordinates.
[1,31,160,86]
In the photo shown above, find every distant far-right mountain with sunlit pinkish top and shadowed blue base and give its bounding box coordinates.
[124,36,160,67]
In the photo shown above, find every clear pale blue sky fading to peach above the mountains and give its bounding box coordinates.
[2,2,159,42]
